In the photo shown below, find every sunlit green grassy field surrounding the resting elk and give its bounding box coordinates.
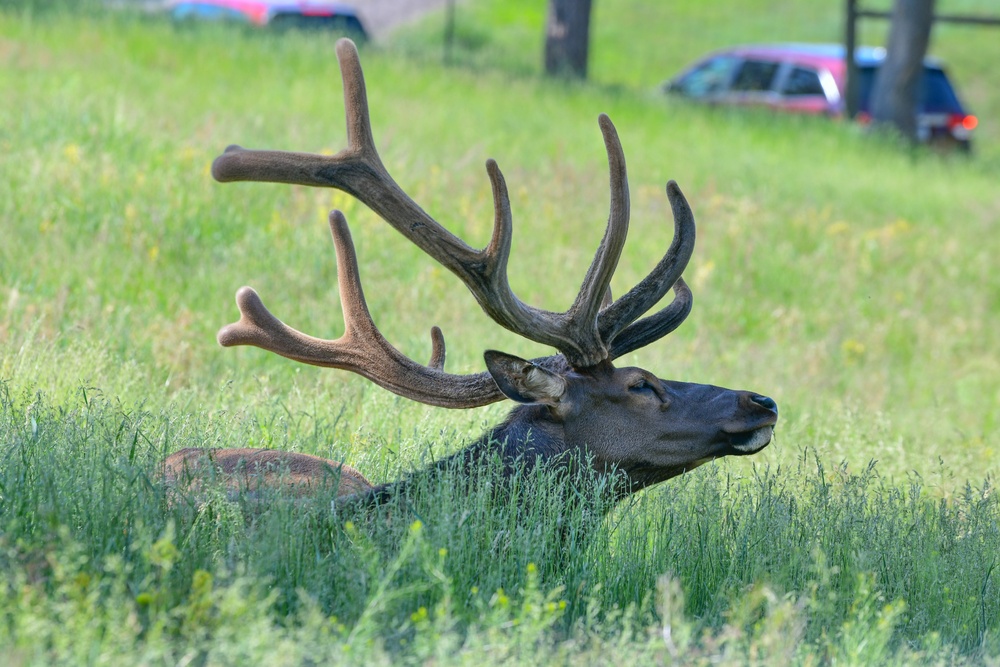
[0,0,1000,664]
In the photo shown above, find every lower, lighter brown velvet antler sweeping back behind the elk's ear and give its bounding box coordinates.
[218,211,503,408]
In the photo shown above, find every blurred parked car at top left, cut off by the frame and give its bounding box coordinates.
[167,0,366,39]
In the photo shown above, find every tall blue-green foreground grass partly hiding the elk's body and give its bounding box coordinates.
[0,385,1000,664]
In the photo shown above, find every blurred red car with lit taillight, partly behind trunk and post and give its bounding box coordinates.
[663,44,978,150]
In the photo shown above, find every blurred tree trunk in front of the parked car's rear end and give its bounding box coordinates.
[871,0,935,141]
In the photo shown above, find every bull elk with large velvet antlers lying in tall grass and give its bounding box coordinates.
[165,40,778,502]
